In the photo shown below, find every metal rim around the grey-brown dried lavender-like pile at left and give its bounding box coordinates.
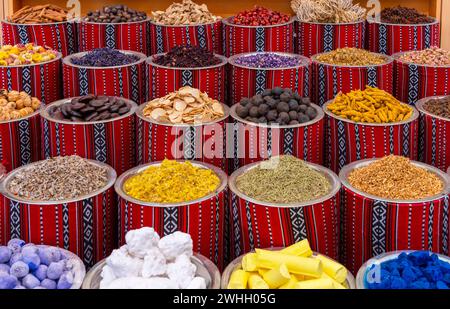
[0,159,117,206]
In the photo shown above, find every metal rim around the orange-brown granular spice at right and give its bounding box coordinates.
[339,158,450,204]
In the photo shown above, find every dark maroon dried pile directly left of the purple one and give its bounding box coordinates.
[153,46,222,68]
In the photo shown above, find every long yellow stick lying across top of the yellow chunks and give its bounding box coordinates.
[256,249,322,278]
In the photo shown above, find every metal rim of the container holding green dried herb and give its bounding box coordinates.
[228,161,341,209]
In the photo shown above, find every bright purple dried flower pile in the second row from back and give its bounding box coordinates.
[234,52,302,69]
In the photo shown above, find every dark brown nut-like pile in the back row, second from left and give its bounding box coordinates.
[83,4,147,24]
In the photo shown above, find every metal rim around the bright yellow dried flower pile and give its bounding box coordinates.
[114,160,227,208]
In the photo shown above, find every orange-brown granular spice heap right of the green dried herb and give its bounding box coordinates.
[348,155,444,200]
